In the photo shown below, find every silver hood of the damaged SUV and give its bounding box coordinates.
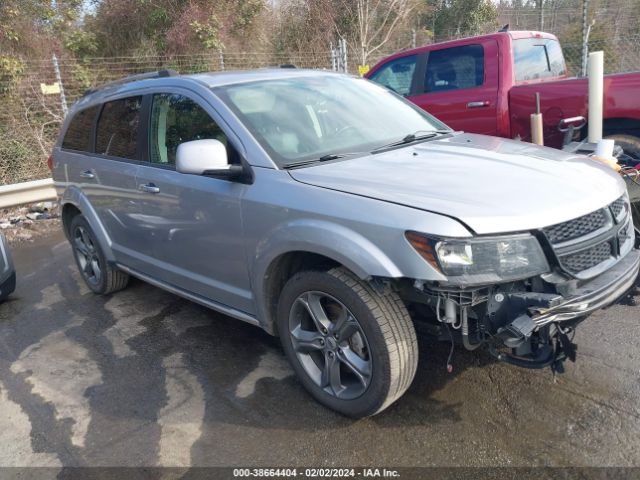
[290,134,625,234]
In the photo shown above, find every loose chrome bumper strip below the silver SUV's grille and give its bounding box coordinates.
[531,249,640,328]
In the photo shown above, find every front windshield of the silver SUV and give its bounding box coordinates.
[215,75,447,167]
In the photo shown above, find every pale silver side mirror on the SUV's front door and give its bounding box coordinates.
[176,139,243,178]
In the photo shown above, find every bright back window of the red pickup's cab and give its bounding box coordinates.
[513,38,566,81]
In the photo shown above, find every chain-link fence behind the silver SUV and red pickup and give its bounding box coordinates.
[0,36,640,185]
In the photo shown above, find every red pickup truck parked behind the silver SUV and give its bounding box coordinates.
[366,31,640,159]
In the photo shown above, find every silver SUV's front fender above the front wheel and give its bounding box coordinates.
[242,168,471,331]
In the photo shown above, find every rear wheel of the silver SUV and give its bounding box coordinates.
[69,215,129,295]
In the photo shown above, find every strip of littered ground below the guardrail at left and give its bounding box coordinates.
[0,202,61,245]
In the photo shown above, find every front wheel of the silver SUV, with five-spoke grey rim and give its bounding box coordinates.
[278,268,418,418]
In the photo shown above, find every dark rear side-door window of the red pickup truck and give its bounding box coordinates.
[424,45,484,92]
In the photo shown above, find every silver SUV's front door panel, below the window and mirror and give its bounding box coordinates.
[135,165,254,314]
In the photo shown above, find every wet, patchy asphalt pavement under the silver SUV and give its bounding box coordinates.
[0,232,640,467]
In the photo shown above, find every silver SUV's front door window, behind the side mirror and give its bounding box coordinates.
[149,93,227,165]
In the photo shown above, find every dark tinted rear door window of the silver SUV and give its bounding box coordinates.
[96,97,142,160]
